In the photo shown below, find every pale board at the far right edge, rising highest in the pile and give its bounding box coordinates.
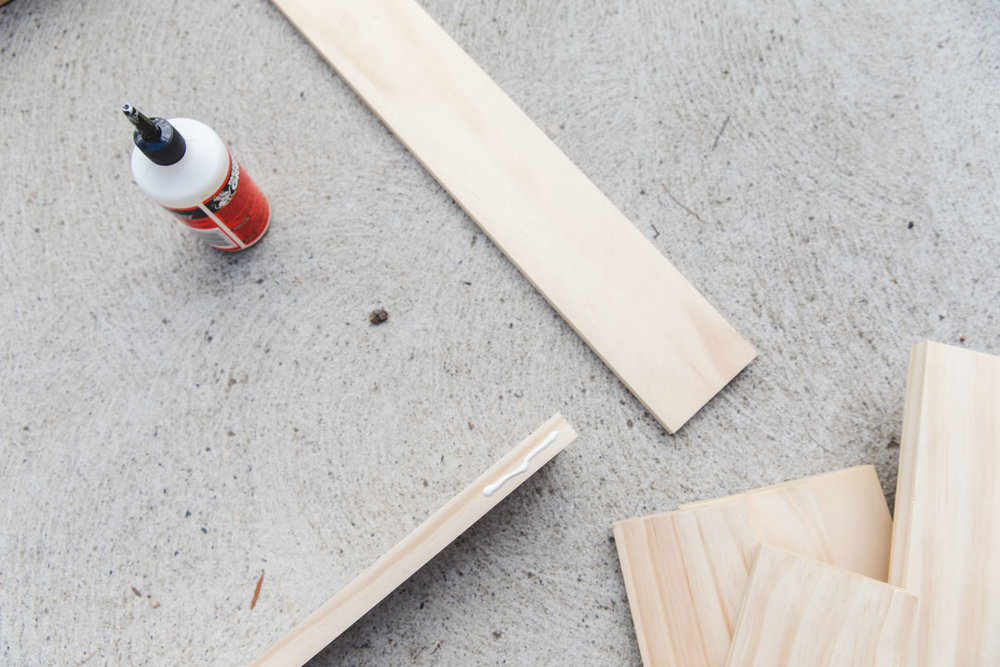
[889,342,1000,666]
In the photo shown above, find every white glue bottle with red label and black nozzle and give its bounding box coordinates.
[122,104,271,252]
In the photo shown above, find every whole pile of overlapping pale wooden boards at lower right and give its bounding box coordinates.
[614,343,1000,666]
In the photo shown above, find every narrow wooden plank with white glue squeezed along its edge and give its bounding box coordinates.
[253,414,576,667]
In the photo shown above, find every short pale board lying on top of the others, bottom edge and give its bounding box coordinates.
[726,545,919,667]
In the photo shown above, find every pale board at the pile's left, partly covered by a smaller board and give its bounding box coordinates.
[614,466,891,667]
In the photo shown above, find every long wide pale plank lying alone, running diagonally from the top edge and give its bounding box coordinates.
[273,0,756,432]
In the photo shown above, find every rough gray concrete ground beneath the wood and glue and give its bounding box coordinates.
[0,0,1000,665]
